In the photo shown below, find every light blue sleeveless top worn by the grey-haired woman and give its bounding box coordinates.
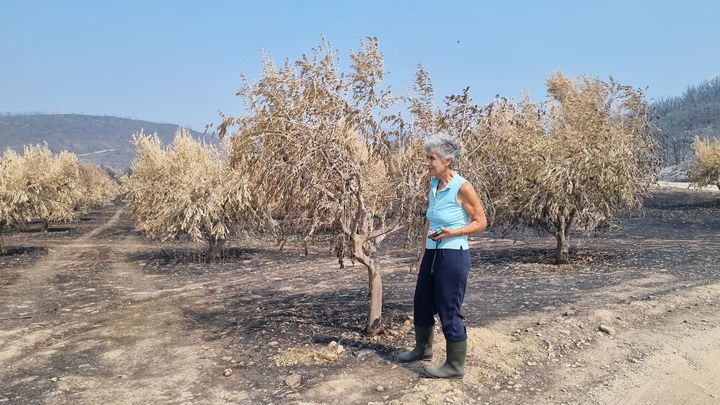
[425,172,470,250]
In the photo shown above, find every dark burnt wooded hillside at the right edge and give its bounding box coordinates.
[654,76,720,164]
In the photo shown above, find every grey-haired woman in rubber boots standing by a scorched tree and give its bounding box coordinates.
[398,134,487,378]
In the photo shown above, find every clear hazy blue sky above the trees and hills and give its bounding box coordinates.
[0,0,720,129]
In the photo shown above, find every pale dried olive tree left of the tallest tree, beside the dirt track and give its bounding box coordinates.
[123,129,251,260]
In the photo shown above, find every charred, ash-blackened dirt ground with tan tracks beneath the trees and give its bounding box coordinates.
[0,185,720,404]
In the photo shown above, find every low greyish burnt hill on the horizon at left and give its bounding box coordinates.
[0,114,216,170]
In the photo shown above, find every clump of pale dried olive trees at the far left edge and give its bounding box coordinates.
[0,145,118,253]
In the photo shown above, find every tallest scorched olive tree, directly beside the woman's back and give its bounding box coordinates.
[219,37,425,335]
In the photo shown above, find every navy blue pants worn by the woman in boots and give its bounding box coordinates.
[413,249,470,342]
